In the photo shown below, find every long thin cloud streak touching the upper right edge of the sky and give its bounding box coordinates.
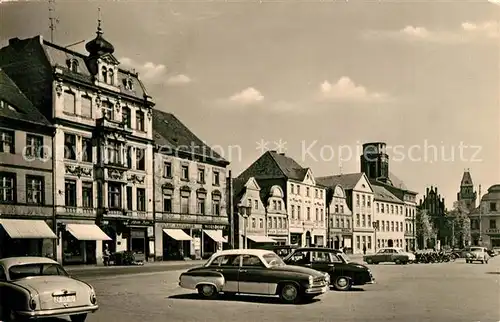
[364,21,499,44]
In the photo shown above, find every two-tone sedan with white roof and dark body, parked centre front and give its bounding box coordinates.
[179,249,330,303]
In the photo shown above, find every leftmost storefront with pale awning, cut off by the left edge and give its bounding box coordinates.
[0,219,57,258]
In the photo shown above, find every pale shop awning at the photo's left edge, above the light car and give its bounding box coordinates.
[0,219,57,239]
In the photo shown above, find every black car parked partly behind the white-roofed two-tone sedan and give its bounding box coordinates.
[284,247,375,291]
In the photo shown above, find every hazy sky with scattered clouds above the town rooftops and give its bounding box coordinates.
[0,0,500,208]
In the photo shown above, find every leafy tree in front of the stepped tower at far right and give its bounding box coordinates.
[446,201,471,247]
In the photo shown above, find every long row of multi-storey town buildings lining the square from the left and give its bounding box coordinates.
[0,26,417,264]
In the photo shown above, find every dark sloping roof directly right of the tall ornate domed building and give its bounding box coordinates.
[153,109,229,165]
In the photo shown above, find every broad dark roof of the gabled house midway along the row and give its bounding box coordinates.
[238,151,309,181]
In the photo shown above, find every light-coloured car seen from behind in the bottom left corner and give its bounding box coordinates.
[0,257,99,322]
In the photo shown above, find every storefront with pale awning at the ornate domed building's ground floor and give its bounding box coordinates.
[57,220,111,265]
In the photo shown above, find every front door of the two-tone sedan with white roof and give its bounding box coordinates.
[238,255,273,294]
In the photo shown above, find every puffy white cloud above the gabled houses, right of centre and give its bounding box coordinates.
[319,76,391,103]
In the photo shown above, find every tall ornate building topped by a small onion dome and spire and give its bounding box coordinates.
[0,22,154,264]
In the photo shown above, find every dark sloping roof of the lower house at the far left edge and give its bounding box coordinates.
[0,68,51,126]
